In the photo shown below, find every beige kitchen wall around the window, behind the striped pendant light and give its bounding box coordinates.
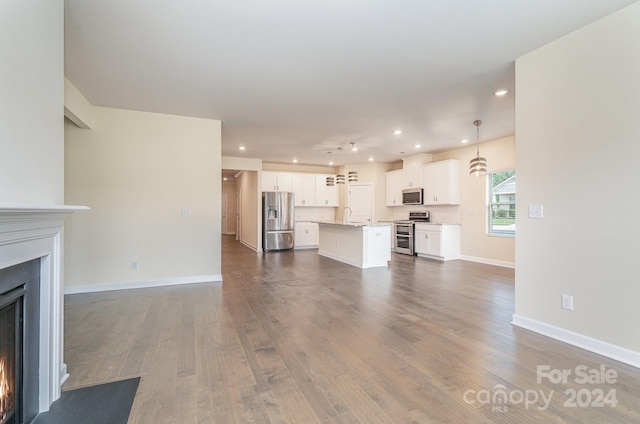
[427,137,520,267]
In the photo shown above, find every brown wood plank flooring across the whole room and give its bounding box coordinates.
[65,236,640,424]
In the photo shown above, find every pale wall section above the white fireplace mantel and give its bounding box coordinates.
[0,0,64,205]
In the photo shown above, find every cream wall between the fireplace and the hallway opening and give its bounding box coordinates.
[64,108,221,289]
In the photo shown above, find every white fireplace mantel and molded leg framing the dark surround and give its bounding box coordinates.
[0,203,89,412]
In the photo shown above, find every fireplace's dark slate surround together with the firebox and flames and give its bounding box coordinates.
[0,259,40,424]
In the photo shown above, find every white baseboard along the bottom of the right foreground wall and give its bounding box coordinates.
[511,314,640,368]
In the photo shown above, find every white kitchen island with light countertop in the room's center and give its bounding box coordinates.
[318,221,392,268]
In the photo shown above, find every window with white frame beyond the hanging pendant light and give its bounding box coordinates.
[487,171,516,236]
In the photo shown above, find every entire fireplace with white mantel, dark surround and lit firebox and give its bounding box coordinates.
[0,203,88,423]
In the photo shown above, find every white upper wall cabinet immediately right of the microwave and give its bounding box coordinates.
[423,159,460,205]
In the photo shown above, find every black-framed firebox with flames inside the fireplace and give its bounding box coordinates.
[0,286,25,424]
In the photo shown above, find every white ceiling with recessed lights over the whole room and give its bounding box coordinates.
[65,0,635,165]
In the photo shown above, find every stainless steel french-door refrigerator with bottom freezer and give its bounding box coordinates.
[262,191,295,252]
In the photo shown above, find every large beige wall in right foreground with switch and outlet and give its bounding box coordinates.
[514,3,640,354]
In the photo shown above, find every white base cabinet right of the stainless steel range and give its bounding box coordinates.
[414,224,460,261]
